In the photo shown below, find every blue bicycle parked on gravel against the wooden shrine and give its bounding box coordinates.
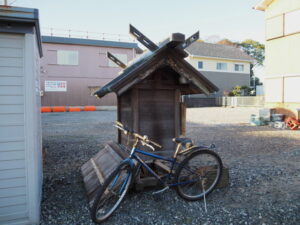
[91,121,223,223]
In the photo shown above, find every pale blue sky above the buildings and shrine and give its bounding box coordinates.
[4,0,264,42]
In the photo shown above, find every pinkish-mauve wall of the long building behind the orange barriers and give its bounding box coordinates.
[41,38,136,106]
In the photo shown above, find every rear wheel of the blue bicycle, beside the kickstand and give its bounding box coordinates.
[175,150,223,201]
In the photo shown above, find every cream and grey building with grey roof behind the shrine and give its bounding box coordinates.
[186,41,253,95]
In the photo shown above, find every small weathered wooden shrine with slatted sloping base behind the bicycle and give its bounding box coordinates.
[82,25,218,207]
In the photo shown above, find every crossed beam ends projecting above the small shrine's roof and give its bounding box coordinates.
[107,24,200,69]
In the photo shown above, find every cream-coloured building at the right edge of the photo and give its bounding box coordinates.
[255,0,300,119]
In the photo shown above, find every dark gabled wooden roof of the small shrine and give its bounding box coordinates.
[94,33,218,97]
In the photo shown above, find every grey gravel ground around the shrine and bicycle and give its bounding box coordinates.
[41,108,300,225]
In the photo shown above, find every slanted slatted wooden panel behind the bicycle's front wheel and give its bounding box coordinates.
[81,142,128,207]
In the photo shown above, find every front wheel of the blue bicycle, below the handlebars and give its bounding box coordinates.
[91,162,132,223]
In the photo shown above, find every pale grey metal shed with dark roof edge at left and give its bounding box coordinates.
[0,6,42,225]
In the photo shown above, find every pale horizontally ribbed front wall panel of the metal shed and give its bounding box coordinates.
[0,34,28,224]
